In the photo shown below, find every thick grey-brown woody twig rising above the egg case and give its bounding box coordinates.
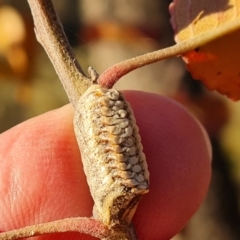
[28,0,92,106]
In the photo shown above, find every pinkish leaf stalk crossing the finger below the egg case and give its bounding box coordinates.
[0,217,108,240]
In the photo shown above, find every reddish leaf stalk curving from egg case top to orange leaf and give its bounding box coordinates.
[97,19,240,88]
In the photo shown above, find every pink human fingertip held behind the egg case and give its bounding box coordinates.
[0,91,211,240]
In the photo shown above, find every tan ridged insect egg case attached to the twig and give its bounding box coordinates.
[74,85,149,226]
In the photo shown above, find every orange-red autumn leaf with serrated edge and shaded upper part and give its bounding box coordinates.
[170,0,240,100]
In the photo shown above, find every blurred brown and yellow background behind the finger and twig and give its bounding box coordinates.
[0,0,240,240]
